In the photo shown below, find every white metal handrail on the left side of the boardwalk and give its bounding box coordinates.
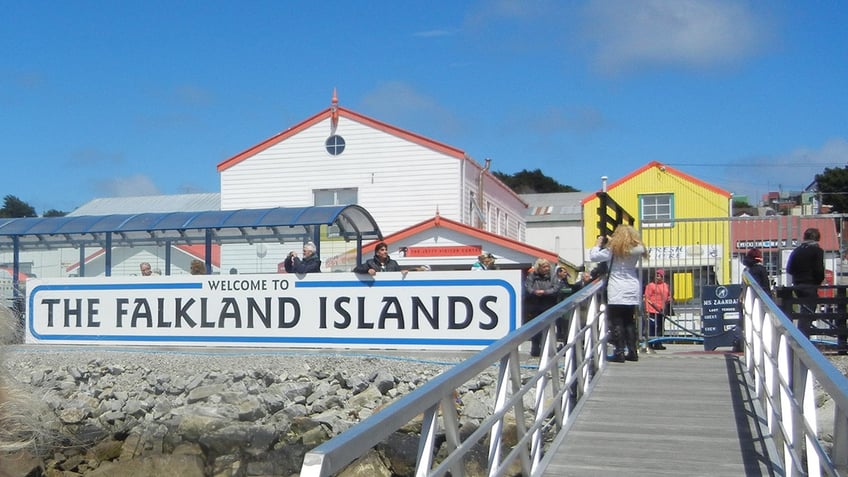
[300,281,607,477]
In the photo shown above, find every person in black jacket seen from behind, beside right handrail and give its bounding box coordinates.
[786,227,824,338]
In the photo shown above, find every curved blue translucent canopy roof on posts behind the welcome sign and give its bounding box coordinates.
[0,205,382,251]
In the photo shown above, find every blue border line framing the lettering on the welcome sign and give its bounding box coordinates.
[27,279,518,346]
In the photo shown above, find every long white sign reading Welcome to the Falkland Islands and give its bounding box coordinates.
[26,270,522,349]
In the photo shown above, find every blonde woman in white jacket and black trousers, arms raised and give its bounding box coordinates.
[589,224,648,363]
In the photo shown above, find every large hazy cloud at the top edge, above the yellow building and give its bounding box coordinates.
[582,0,770,73]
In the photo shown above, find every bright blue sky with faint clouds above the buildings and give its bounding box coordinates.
[0,0,848,214]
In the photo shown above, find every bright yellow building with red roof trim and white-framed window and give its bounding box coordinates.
[583,161,732,302]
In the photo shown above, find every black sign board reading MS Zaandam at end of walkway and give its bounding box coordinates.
[701,285,742,351]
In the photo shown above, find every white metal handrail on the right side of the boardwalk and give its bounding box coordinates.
[742,271,848,476]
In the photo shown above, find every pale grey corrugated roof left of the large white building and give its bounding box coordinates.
[68,192,221,217]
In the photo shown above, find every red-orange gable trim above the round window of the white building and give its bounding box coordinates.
[218,106,465,172]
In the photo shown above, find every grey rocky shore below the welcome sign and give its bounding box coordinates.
[0,345,495,477]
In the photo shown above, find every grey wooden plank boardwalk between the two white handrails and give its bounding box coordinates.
[544,345,779,477]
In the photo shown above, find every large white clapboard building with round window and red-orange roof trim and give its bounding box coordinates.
[218,93,527,241]
